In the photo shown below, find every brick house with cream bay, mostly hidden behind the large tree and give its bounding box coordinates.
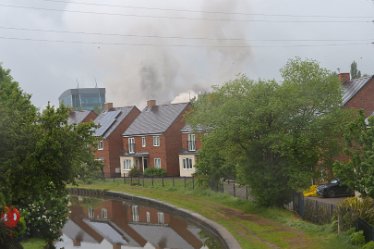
[179,124,205,176]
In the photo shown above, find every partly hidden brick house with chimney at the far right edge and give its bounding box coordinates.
[339,73,374,117]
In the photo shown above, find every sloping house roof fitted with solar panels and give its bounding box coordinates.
[94,106,136,138]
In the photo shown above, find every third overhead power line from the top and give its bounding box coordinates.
[0,26,374,42]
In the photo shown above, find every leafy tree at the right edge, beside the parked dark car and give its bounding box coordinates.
[334,112,374,198]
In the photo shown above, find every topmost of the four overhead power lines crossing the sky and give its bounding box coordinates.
[41,0,374,19]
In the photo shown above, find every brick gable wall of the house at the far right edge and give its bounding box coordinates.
[345,77,374,117]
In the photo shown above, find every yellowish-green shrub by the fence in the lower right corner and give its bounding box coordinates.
[335,197,374,230]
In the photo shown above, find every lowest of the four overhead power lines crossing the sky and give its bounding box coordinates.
[0,36,374,48]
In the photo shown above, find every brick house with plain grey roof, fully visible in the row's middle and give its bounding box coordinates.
[120,100,190,176]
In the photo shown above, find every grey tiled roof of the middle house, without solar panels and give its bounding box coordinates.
[123,103,189,136]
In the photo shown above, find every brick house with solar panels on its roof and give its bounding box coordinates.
[94,103,140,177]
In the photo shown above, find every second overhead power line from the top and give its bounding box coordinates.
[0,3,372,23]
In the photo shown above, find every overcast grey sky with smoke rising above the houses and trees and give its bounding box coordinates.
[0,0,374,107]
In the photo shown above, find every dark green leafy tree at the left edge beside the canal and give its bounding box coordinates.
[0,63,100,248]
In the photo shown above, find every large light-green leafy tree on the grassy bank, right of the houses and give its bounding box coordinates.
[189,58,350,205]
